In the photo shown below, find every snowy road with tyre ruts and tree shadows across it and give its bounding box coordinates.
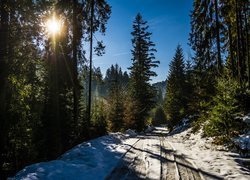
[106,130,203,180]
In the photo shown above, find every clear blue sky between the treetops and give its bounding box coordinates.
[93,0,193,82]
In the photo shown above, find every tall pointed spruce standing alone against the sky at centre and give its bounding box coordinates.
[128,14,160,131]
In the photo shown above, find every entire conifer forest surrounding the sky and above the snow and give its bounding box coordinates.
[0,0,250,179]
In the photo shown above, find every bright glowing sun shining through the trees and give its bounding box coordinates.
[46,15,61,36]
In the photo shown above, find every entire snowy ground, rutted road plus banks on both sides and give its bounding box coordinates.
[10,128,250,180]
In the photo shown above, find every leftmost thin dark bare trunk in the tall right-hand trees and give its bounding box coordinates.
[215,0,222,72]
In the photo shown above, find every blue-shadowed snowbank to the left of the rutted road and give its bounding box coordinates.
[9,130,138,180]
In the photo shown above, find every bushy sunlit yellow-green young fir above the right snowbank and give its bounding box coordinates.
[204,75,242,137]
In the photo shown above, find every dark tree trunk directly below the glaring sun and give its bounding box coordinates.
[45,39,62,159]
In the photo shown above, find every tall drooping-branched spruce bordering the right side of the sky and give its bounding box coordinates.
[189,0,221,113]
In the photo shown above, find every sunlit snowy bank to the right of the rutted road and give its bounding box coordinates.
[166,128,250,180]
